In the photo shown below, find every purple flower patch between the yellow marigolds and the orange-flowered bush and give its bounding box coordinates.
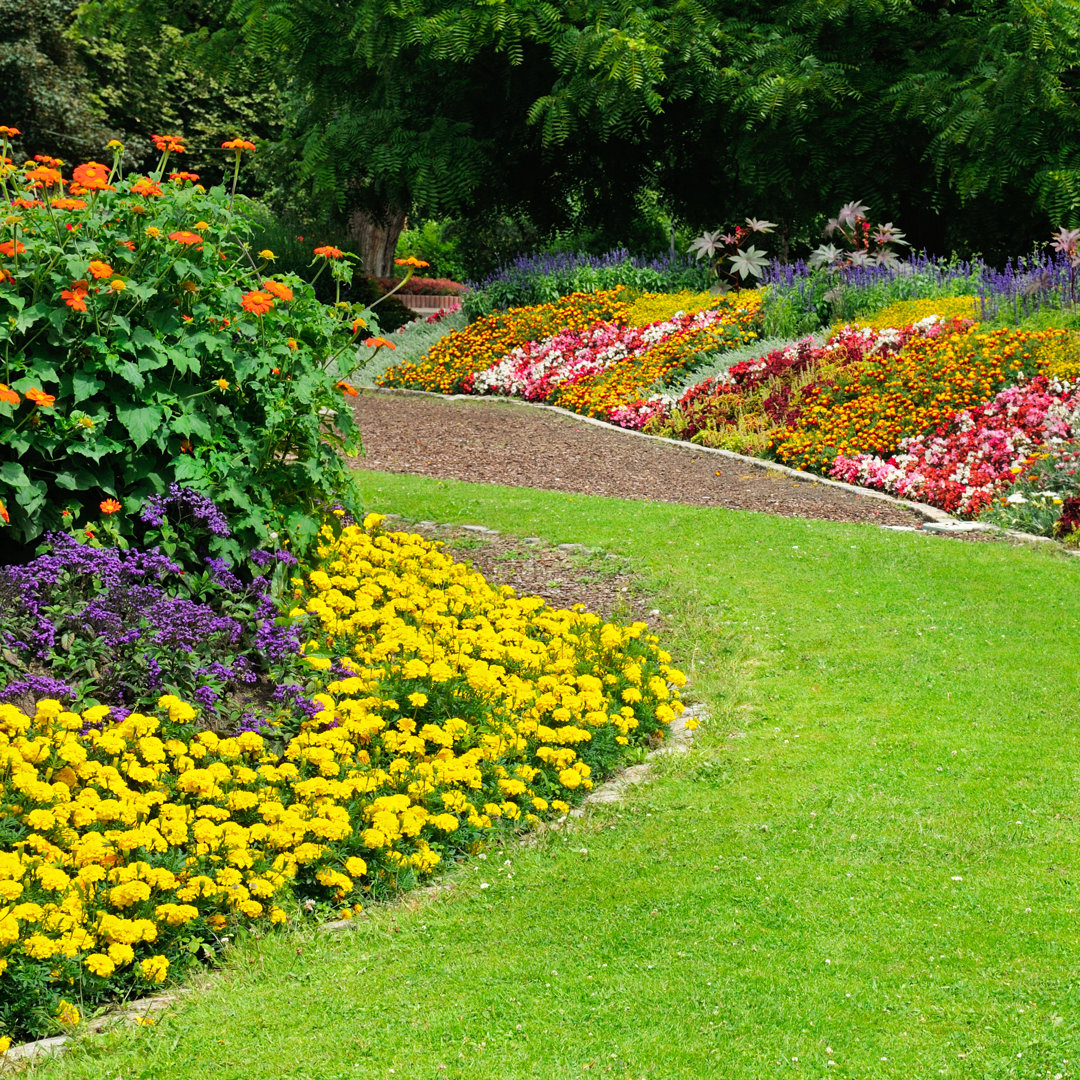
[0,522,304,725]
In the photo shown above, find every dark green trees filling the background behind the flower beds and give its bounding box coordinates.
[0,0,1080,273]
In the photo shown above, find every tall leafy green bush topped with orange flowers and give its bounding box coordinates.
[0,138,372,551]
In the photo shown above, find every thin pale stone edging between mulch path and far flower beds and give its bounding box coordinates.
[363,387,1080,555]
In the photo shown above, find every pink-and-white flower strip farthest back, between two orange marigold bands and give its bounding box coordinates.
[473,310,731,401]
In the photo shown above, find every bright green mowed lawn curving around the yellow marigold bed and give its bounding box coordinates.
[33,474,1080,1080]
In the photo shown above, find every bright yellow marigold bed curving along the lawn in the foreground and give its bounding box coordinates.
[0,515,685,1034]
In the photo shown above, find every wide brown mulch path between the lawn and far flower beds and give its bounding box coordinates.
[353,391,922,526]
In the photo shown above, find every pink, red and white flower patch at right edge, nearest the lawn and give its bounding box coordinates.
[829,376,1080,516]
